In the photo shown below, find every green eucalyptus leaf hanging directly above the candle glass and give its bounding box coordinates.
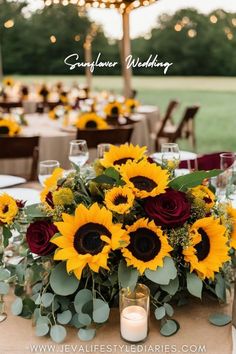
[118,260,139,290]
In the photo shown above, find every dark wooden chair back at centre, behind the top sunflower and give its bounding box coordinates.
[77,125,133,149]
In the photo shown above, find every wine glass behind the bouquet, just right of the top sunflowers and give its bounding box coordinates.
[161,143,180,176]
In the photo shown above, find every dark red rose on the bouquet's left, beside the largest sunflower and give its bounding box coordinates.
[26,221,58,256]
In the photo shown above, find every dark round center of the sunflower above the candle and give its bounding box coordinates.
[127,227,161,262]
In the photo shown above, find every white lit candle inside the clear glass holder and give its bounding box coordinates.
[120,305,148,342]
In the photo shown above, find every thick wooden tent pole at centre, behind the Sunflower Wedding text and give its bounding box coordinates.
[121,11,132,98]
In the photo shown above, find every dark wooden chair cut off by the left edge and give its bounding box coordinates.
[0,136,39,181]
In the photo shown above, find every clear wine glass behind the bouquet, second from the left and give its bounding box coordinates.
[69,140,89,167]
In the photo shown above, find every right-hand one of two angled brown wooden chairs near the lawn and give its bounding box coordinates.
[156,106,200,151]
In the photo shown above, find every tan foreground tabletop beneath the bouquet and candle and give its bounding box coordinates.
[0,296,232,354]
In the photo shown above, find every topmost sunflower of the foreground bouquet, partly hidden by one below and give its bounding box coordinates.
[101,144,147,168]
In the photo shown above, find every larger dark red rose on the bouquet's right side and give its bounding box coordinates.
[144,189,191,227]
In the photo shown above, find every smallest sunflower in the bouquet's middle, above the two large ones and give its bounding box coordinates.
[105,187,134,214]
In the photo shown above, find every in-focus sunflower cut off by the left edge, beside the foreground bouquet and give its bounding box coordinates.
[0,193,18,224]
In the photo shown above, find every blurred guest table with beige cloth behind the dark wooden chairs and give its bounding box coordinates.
[0,114,153,176]
